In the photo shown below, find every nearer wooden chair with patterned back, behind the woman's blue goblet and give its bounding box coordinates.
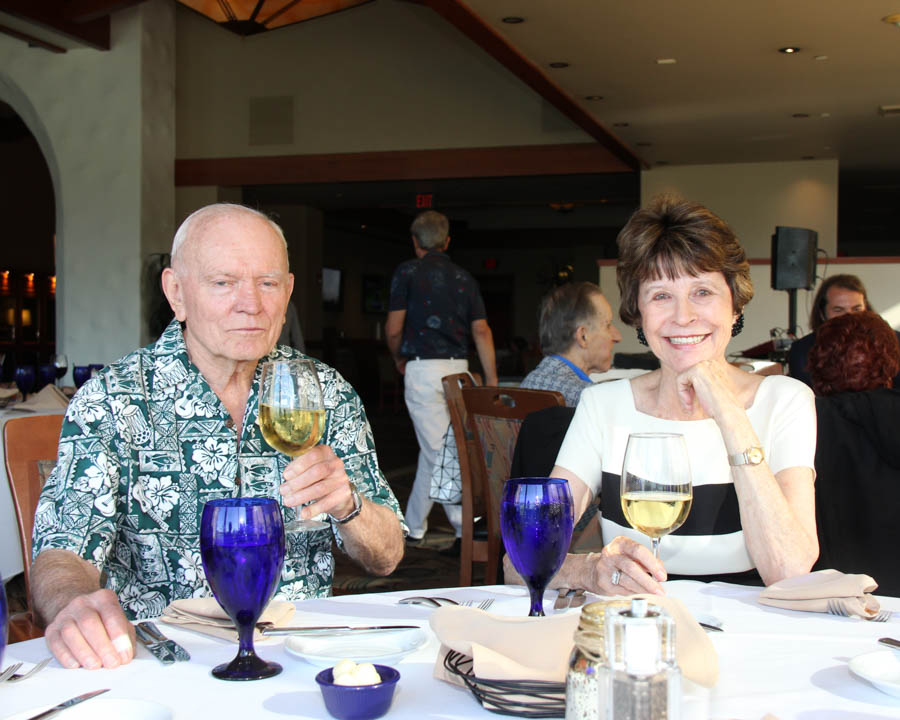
[460,387,566,585]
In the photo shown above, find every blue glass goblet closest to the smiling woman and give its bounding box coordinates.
[500,478,574,617]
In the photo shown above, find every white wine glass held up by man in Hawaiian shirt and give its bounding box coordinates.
[259,359,328,532]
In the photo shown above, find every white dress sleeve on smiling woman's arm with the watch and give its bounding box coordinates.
[766,377,816,476]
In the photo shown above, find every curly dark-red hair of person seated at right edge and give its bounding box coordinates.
[809,310,900,395]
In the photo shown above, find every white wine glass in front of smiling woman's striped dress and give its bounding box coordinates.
[620,433,694,559]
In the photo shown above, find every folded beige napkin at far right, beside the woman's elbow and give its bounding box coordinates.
[759,570,879,620]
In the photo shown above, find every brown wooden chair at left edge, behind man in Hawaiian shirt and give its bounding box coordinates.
[3,414,64,642]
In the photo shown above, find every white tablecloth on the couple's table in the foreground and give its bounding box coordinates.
[0,580,900,720]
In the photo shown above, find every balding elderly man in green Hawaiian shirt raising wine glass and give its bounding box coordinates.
[31,205,404,668]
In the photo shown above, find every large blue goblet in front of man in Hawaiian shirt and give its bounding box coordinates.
[200,497,284,680]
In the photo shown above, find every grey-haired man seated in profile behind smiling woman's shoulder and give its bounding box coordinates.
[520,282,622,407]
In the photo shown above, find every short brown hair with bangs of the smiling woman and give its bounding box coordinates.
[616,195,753,327]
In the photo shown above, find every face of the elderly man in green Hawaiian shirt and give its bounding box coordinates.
[167,213,294,369]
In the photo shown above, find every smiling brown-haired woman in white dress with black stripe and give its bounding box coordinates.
[540,197,818,594]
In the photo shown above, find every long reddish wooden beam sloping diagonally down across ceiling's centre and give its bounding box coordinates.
[406,0,643,171]
